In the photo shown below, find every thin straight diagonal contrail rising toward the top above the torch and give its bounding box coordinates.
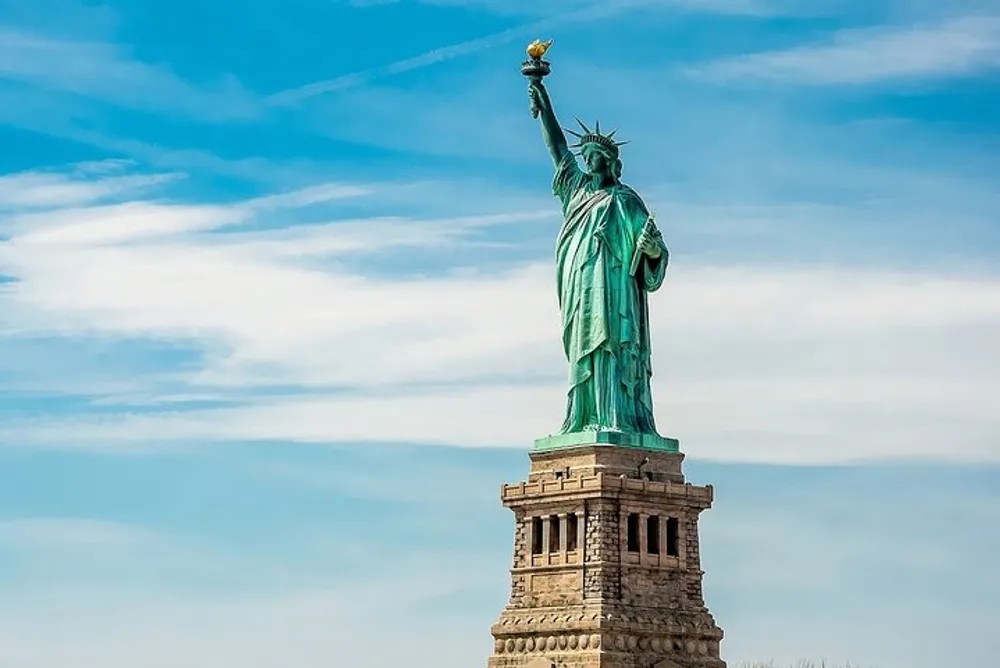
[265,0,650,106]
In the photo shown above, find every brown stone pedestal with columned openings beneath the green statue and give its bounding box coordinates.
[488,439,726,668]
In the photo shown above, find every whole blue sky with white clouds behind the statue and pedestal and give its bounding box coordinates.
[0,0,1000,668]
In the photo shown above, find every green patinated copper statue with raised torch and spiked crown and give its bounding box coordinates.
[522,44,677,451]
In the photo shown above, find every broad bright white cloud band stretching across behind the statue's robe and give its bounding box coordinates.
[0,163,1000,462]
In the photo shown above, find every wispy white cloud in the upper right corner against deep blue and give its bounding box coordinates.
[688,16,1000,85]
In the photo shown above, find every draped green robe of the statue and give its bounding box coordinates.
[553,153,668,434]
